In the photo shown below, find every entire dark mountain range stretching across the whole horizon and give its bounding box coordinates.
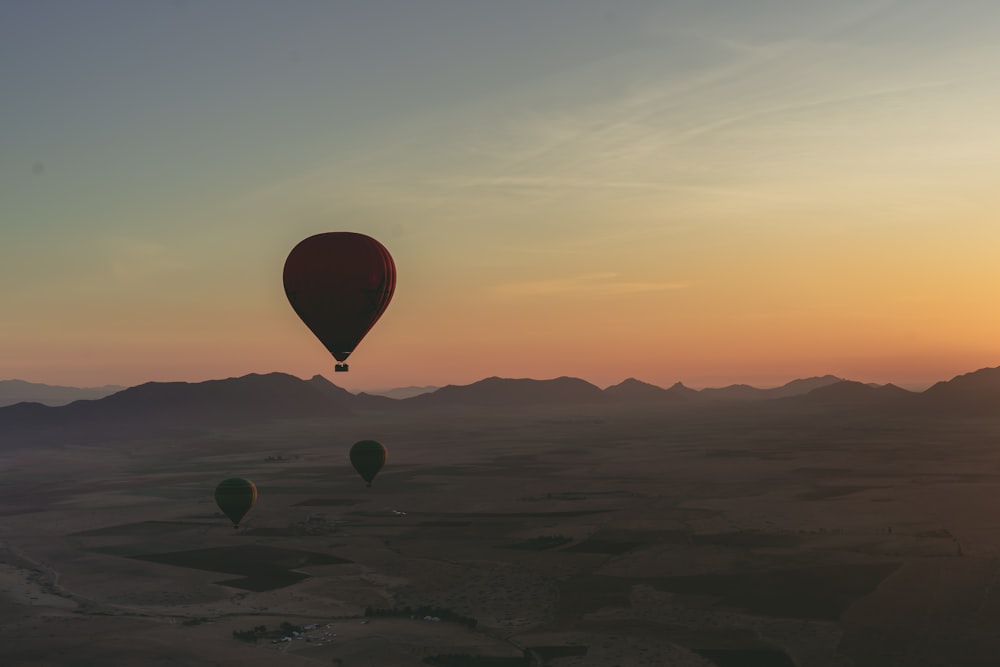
[0,368,1000,448]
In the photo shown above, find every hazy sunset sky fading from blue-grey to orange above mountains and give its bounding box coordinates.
[0,0,1000,391]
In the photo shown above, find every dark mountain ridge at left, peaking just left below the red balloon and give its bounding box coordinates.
[0,373,351,444]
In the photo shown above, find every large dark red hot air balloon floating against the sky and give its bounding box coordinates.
[284,232,396,372]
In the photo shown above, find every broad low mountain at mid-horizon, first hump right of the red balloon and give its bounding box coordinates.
[400,377,605,407]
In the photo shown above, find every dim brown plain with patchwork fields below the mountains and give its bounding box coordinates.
[0,402,1000,667]
